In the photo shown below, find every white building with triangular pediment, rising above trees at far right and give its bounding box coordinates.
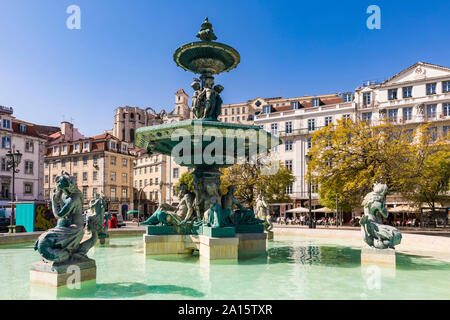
[354,62,450,135]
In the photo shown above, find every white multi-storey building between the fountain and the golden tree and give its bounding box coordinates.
[255,93,355,205]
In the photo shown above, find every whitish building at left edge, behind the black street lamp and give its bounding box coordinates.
[0,106,50,207]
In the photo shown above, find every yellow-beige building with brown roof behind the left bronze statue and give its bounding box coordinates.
[44,122,134,218]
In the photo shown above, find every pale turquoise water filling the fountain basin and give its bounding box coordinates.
[0,237,450,299]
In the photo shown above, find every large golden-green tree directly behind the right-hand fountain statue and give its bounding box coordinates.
[307,120,418,211]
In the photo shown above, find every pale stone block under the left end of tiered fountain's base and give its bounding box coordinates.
[144,234,195,256]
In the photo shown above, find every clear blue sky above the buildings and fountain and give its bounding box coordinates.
[0,0,450,135]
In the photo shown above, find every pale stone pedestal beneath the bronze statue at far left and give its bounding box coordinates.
[30,259,97,287]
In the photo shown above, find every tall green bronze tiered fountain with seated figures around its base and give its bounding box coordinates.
[135,18,280,260]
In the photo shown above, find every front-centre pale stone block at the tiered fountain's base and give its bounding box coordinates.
[199,235,239,260]
